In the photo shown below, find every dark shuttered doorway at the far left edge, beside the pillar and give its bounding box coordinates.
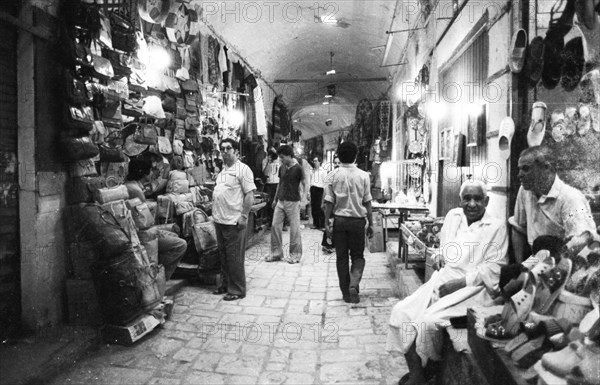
[0,2,21,340]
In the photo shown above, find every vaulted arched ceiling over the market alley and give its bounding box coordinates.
[194,0,403,139]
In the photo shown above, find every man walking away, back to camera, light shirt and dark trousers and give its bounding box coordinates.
[325,142,373,303]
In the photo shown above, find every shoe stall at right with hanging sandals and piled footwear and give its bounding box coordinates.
[467,0,600,384]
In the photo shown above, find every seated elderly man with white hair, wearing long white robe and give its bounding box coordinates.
[386,181,508,384]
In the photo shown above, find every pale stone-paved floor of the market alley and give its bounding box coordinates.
[50,225,407,385]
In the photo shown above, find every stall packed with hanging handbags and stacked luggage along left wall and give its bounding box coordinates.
[48,0,266,344]
